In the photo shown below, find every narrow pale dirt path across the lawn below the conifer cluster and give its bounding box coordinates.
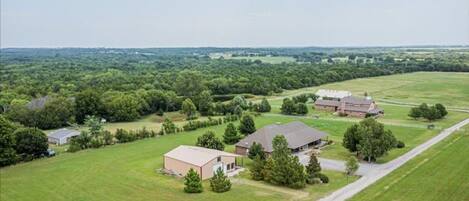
[231,177,309,201]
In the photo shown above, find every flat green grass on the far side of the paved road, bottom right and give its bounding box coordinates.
[351,126,469,201]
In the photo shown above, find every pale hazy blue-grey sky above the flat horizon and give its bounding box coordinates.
[0,0,469,48]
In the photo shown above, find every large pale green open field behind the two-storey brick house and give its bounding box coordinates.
[270,72,469,109]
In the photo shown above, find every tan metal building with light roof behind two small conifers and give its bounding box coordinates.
[164,145,239,179]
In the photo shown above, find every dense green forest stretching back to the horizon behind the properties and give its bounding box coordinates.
[0,47,469,129]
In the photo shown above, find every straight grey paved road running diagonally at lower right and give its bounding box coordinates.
[320,119,469,201]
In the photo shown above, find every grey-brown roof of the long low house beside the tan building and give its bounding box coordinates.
[236,121,327,152]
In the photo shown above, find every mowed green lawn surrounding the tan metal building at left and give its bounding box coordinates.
[0,117,356,201]
